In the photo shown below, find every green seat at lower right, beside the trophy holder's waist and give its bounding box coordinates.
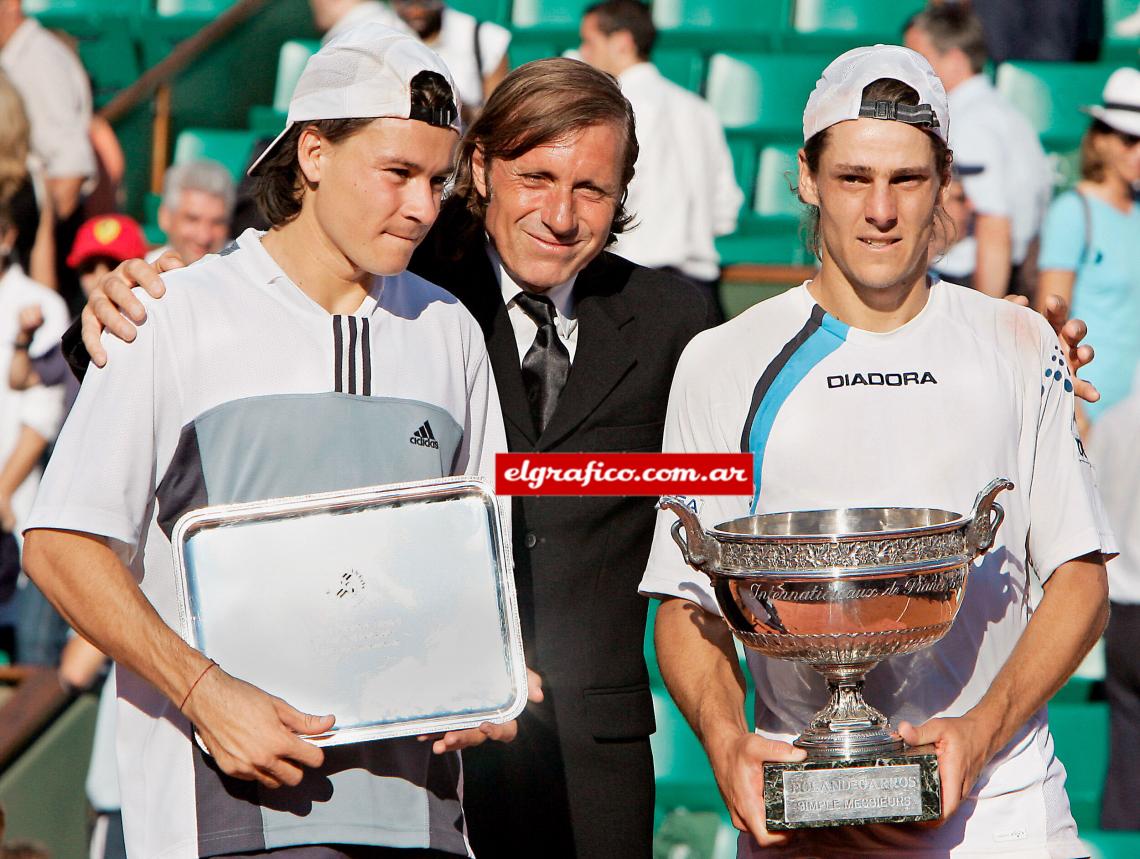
[1049,702,1108,832]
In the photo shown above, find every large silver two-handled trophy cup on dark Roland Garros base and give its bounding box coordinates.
[658,478,1013,829]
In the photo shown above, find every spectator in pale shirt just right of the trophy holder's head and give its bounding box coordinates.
[904,6,1052,297]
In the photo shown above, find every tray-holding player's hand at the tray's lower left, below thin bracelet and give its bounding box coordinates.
[184,665,335,787]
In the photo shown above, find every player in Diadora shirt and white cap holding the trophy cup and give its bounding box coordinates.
[641,46,1115,859]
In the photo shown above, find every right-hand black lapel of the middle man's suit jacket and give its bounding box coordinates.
[538,256,636,449]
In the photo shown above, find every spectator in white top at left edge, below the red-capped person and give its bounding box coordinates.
[0,205,67,662]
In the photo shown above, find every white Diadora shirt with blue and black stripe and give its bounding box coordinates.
[641,277,1115,859]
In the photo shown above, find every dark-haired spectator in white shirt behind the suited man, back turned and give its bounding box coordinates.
[580,0,744,321]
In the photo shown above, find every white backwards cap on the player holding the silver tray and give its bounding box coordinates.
[249,22,462,175]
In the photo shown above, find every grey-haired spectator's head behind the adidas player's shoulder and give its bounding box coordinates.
[147,158,236,265]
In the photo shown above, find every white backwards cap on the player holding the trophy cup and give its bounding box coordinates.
[804,44,950,142]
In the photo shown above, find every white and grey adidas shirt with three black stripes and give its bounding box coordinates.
[26,230,510,859]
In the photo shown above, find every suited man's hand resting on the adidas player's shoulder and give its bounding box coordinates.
[81,251,182,367]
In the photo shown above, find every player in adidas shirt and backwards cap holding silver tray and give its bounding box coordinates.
[25,24,528,859]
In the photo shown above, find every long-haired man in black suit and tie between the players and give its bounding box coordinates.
[64,59,713,859]
